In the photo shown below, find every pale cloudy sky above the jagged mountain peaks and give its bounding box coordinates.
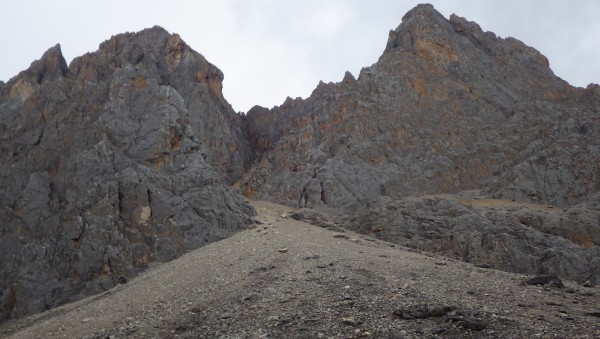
[0,0,600,112]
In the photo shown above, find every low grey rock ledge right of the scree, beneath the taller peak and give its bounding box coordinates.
[353,195,600,283]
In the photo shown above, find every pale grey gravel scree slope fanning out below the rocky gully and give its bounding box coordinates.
[0,202,600,338]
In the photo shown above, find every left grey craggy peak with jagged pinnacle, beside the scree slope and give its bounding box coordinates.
[0,27,254,322]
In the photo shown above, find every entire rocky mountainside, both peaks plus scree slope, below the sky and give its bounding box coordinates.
[0,1,600,337]
